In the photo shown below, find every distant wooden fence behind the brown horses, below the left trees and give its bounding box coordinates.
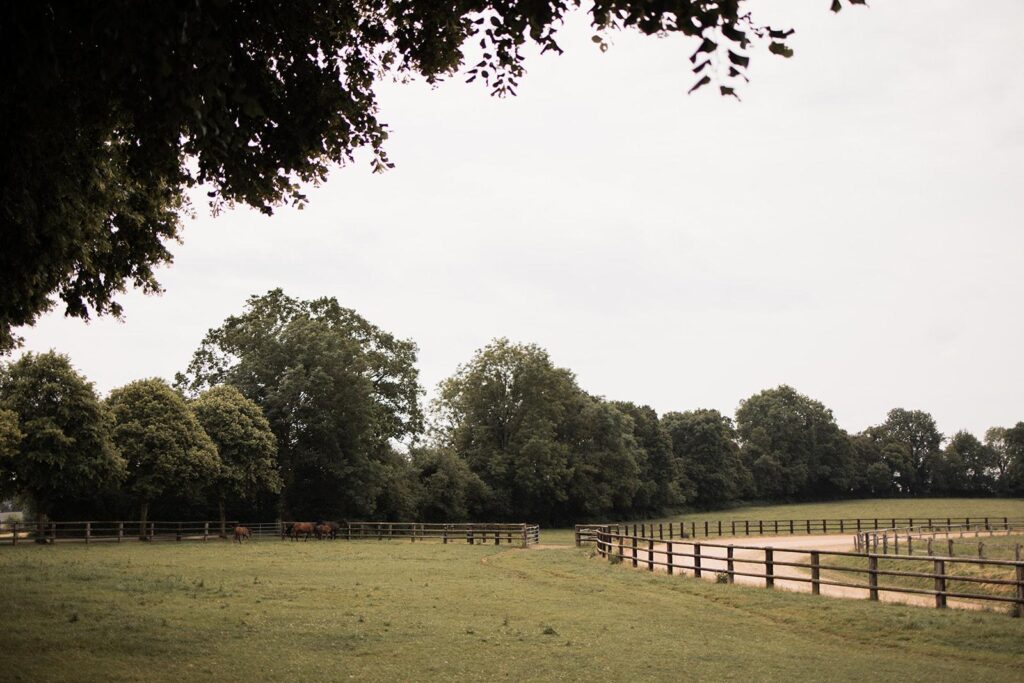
[0,520,541,547]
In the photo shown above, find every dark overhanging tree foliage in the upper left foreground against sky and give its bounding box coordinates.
[0,0,862,350]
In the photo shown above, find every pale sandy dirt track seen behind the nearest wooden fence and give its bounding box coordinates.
[612,535,984,609]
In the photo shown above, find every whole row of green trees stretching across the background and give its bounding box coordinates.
[0,290,1024,523]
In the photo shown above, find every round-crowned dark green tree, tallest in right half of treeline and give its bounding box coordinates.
[736,385,852,499]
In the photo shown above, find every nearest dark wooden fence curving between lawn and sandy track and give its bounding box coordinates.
[596,525,1024,616]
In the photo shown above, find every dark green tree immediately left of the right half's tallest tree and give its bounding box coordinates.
[662,410,753,508]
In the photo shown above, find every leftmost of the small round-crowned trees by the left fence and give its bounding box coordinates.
[0,351,125,533]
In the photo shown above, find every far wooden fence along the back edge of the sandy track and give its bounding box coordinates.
[575,516,1024,546]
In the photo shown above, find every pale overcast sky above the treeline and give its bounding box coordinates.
[16,0,1024,436]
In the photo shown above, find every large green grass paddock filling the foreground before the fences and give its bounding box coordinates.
[0,541,1024,682]
